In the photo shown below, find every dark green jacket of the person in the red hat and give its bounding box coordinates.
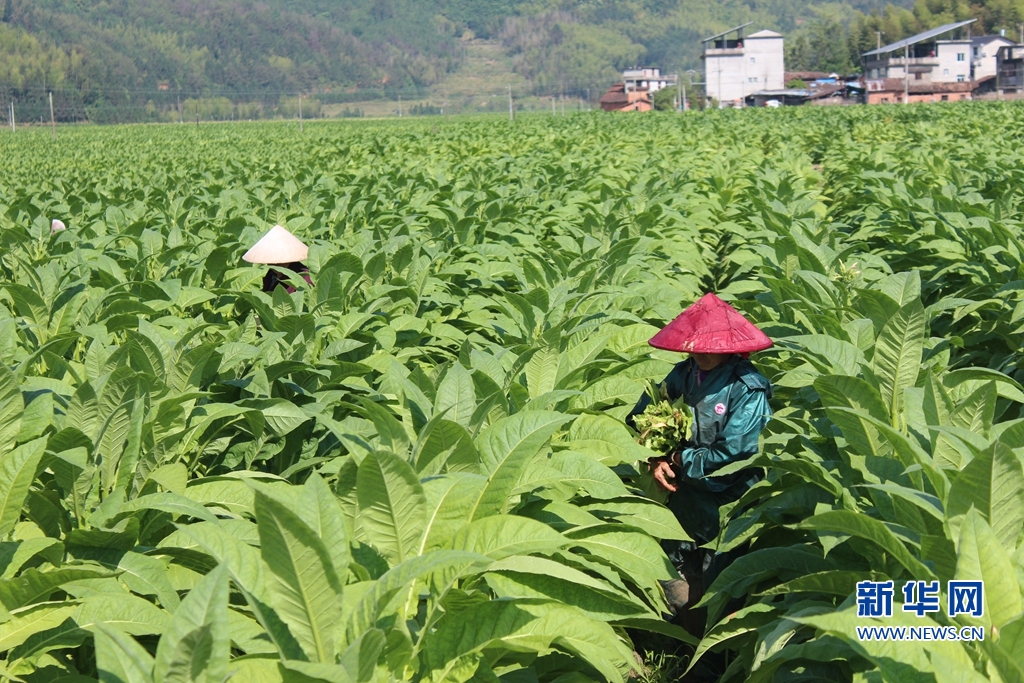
[630,355,772,494]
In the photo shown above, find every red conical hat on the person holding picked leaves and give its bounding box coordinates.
[648,293,772,353]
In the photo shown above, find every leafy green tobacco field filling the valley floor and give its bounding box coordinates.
[0,102,1024,683]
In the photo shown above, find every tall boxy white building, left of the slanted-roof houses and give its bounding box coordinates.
[700,24,785,105]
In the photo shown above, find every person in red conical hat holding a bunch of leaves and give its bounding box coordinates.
[627,294,772,614]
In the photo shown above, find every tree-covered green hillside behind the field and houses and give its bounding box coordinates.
[0,0,1024,120]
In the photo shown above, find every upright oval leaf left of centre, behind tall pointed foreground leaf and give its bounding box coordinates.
[355,451,427,565]
